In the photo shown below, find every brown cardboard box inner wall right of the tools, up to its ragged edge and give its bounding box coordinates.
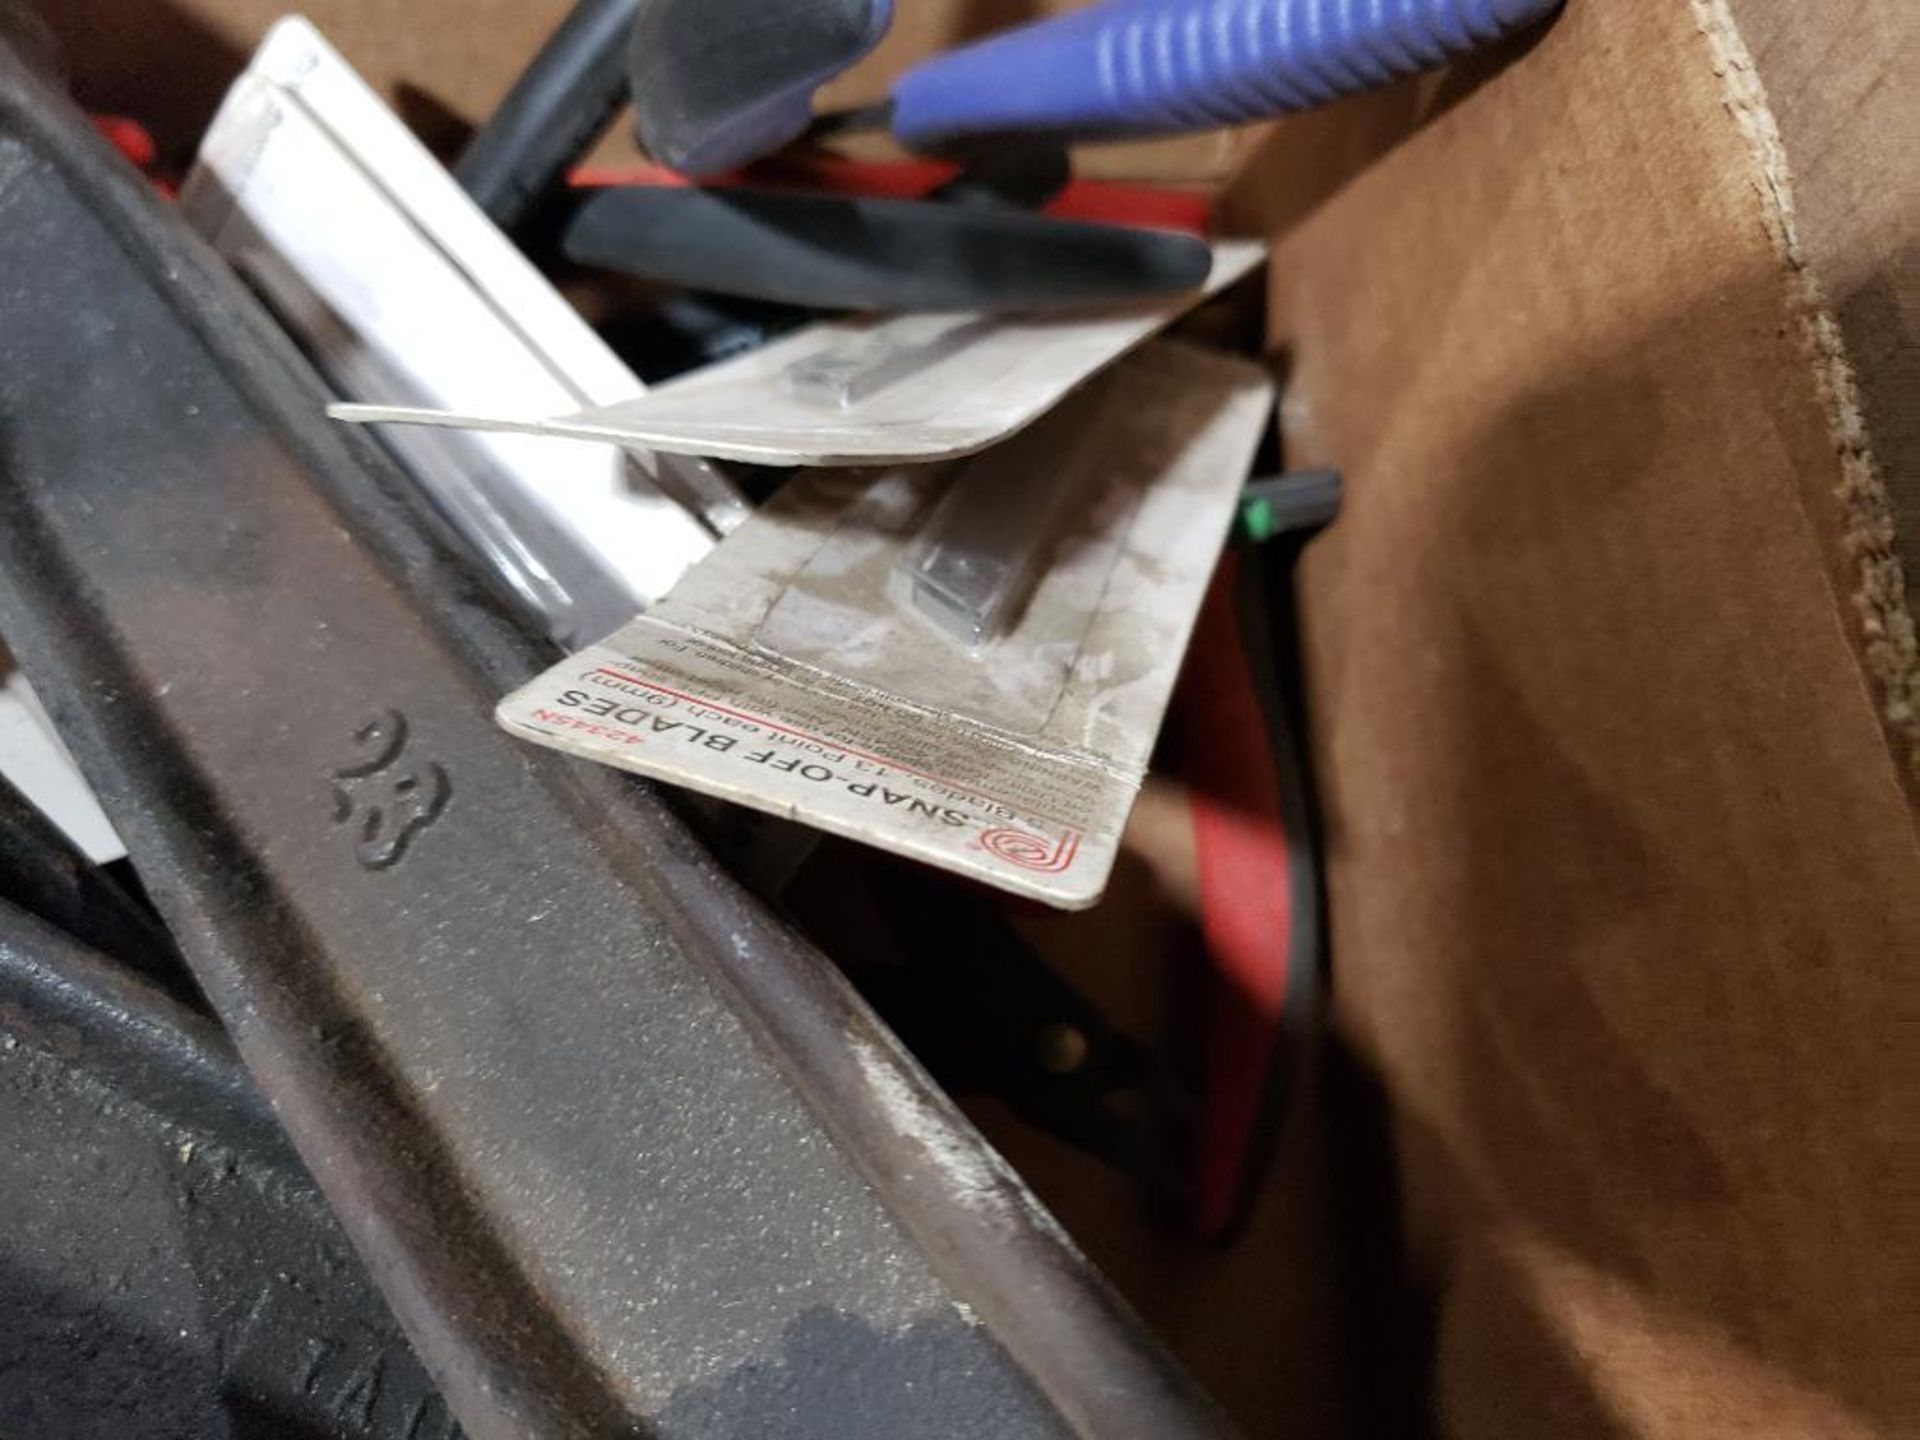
[1236,4,1920,1436]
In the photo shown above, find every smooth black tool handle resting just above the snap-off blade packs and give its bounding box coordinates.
[563,186,1213,313]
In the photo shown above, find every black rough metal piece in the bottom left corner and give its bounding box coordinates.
[0,902,459,1440]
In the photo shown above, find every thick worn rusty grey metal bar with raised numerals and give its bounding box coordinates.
[0,33,1219,1440]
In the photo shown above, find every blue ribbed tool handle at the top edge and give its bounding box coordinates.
[893,0,1559,150]
